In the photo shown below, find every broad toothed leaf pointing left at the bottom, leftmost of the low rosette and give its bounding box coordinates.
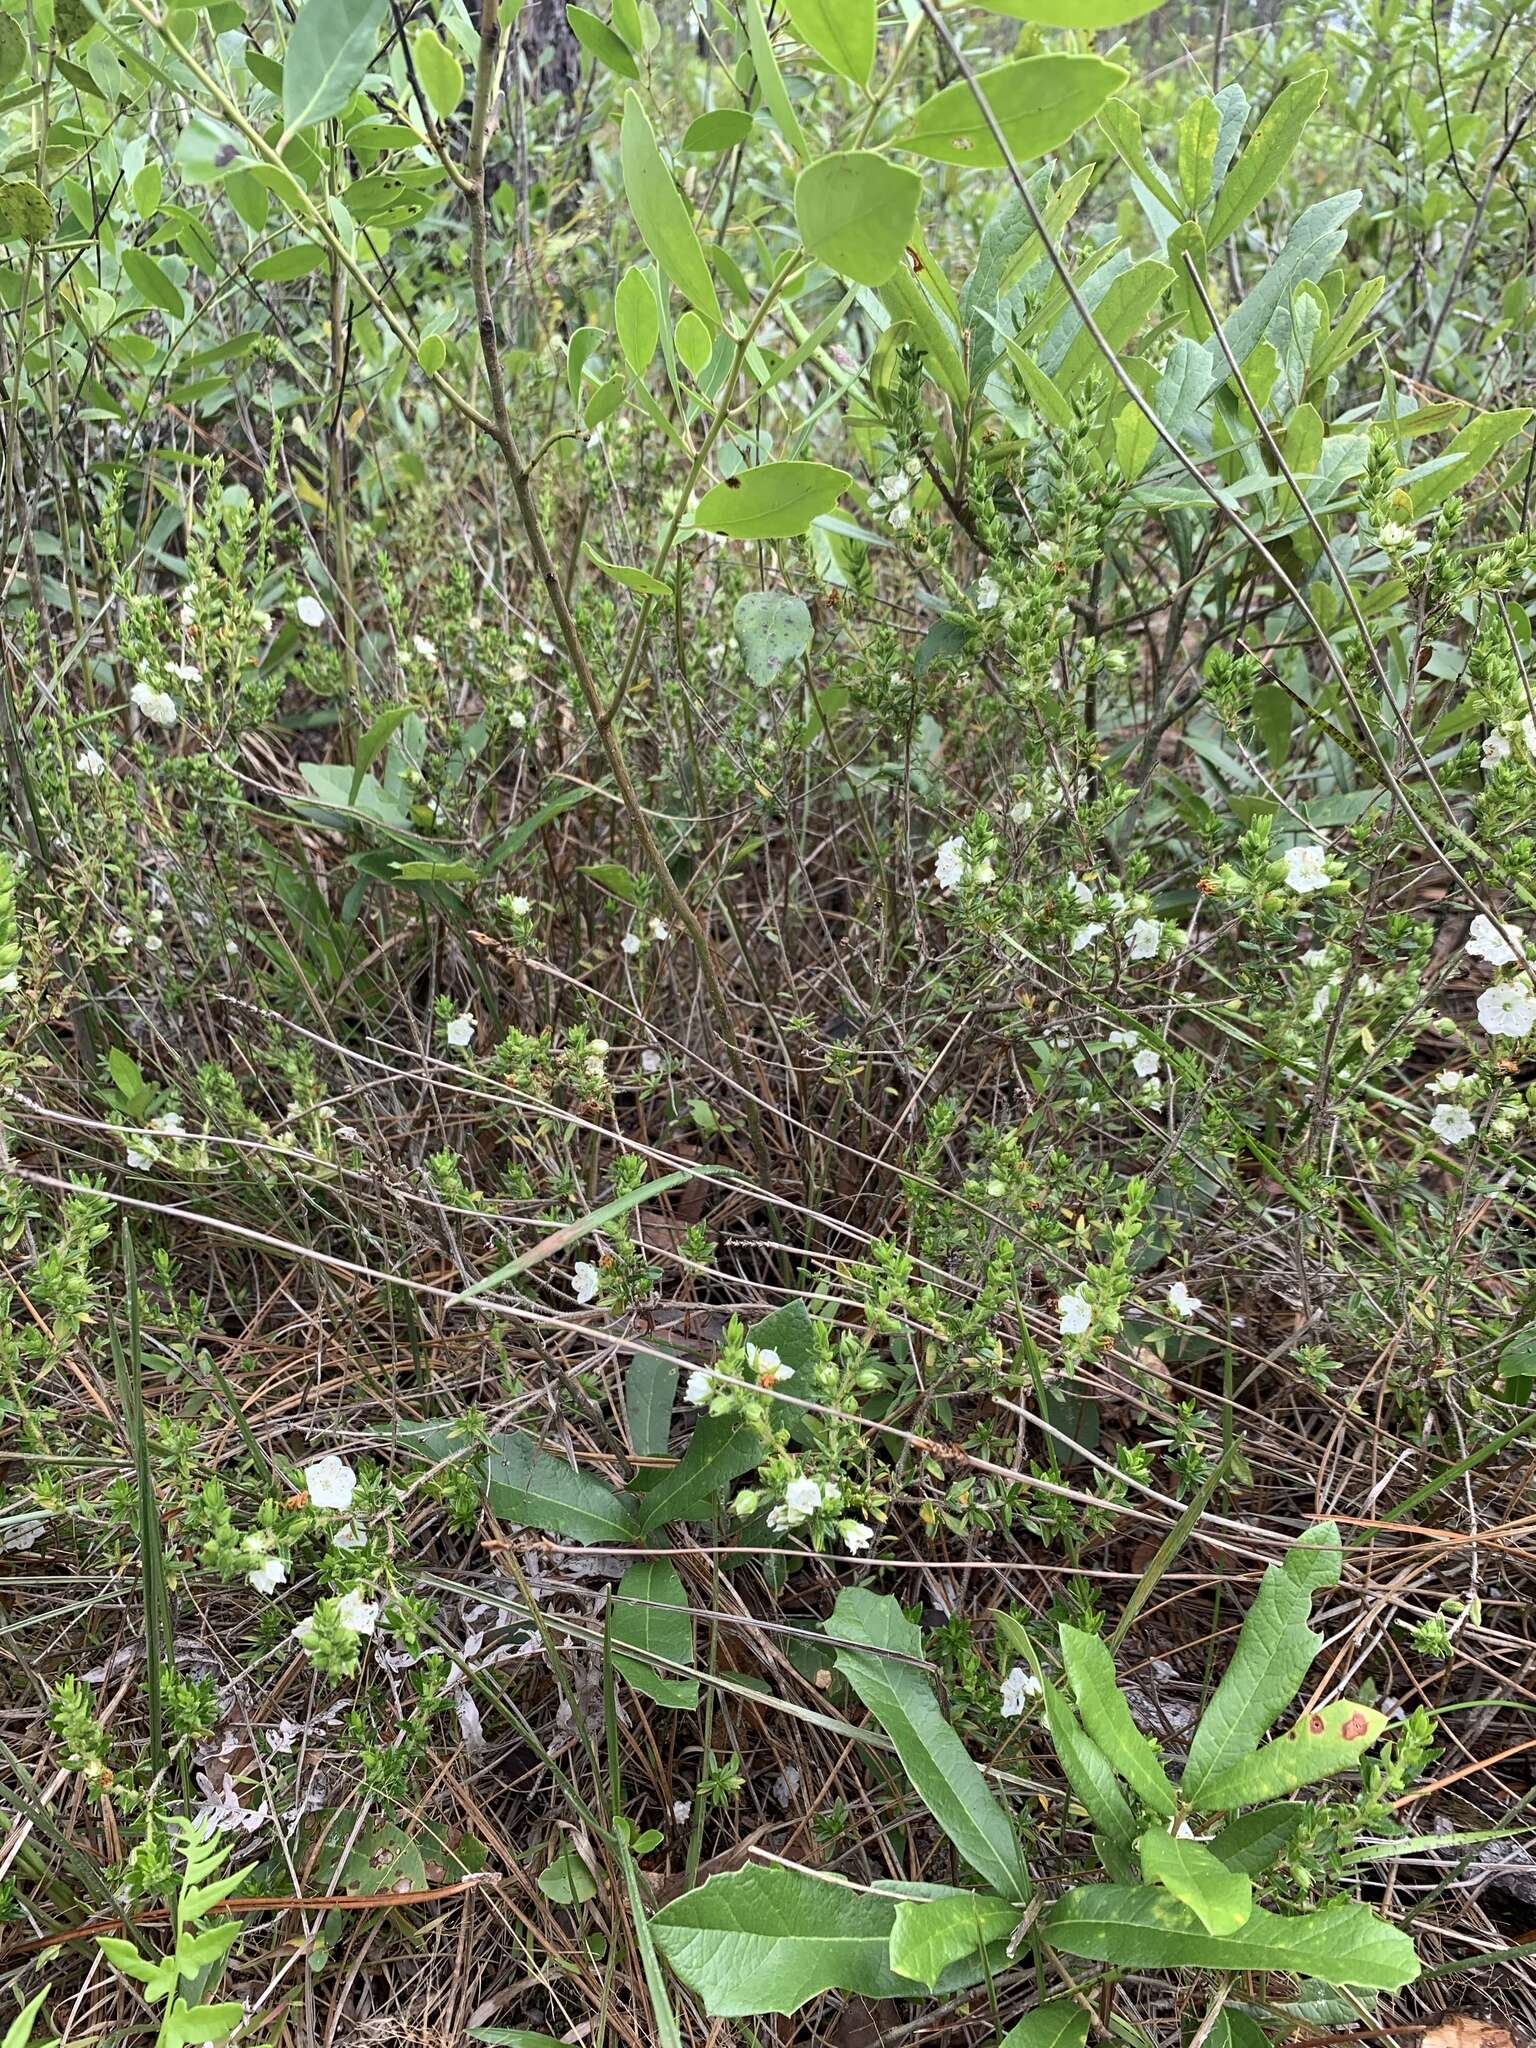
[651,1864,911,2019]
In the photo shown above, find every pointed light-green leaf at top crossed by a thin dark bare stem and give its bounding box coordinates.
[893,55,1126,170]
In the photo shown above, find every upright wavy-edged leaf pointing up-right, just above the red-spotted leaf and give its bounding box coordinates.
[1180,1522,1339,1806]
